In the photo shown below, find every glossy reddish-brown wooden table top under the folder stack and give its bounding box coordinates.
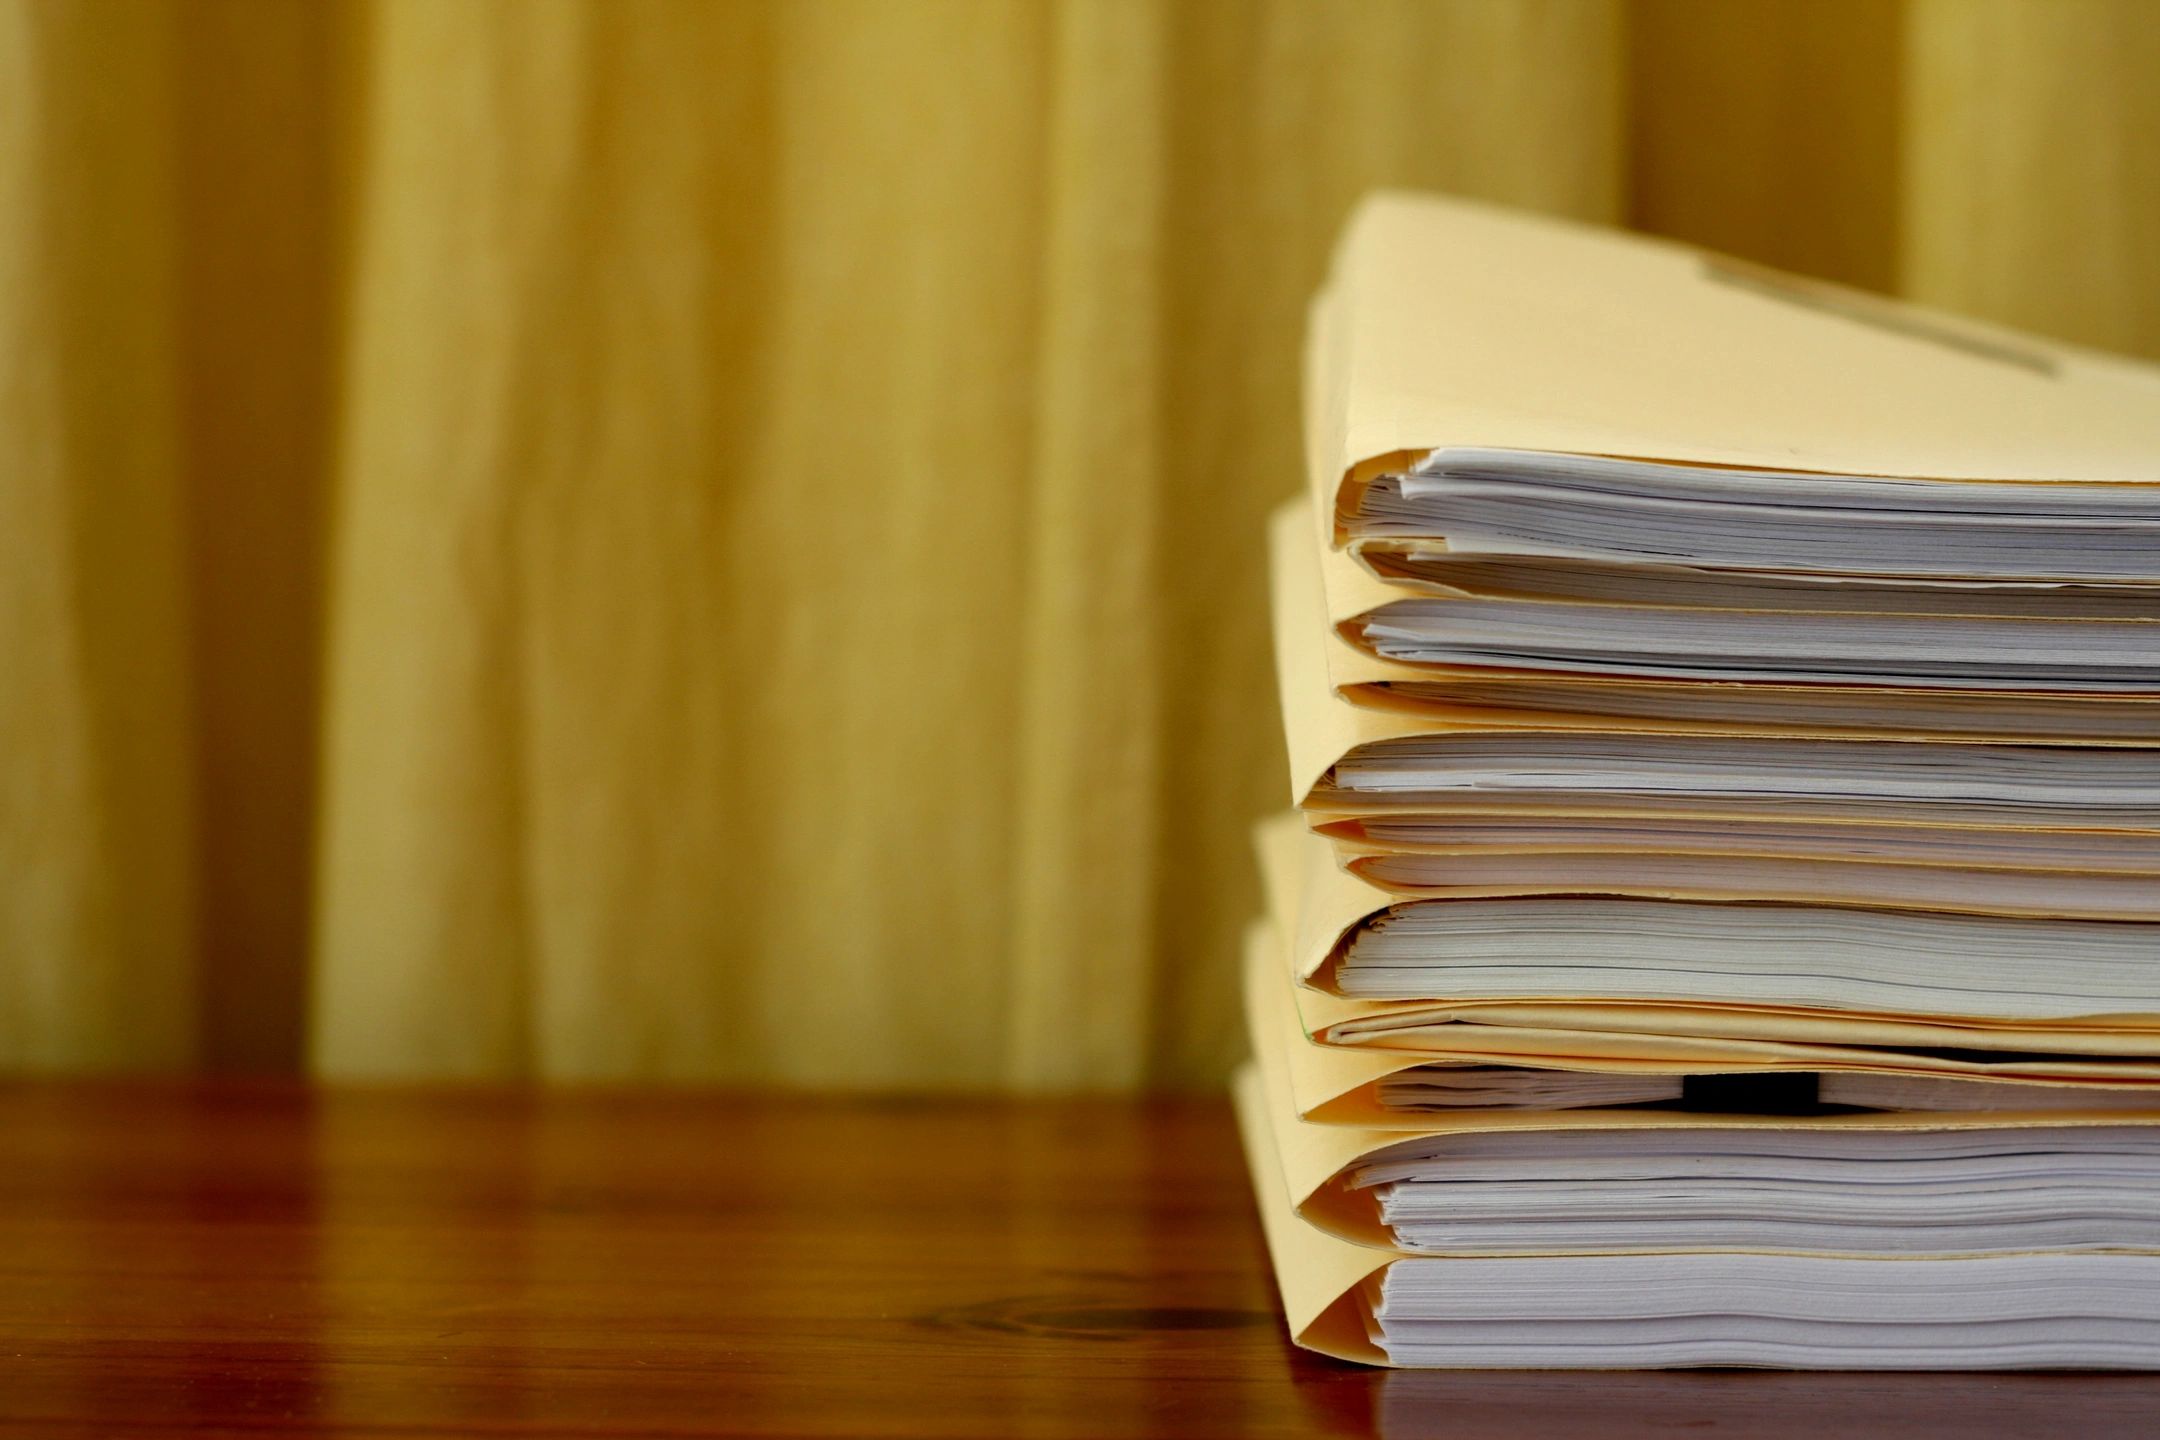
[0,1084,2160,1440]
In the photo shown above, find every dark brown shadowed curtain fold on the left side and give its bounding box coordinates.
[177,0,352,1071]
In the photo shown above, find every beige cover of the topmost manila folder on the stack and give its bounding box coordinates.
[1309,194,2160,548]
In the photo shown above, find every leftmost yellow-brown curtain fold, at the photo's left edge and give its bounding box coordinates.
[0,4,197,1071]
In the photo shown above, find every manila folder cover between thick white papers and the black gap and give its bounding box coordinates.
[1255,816,2160,1057]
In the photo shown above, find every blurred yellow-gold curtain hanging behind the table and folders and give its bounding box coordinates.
[0,0,2160,1090]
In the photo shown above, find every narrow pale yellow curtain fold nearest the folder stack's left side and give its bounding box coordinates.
[994,0,1171,1090]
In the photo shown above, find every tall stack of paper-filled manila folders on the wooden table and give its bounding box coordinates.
[1238,196,2160,1369]
